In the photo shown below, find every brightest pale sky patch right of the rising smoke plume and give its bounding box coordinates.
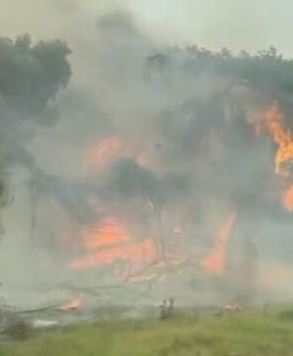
[129,0,293,52]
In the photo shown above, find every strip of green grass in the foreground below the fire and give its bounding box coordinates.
[0,311,293,356]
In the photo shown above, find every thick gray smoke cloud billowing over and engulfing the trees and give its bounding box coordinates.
[0,1,292,308]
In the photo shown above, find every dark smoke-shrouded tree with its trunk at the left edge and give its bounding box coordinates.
[0,35,71,242]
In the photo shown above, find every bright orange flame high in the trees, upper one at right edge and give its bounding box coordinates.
[262,104,293,176]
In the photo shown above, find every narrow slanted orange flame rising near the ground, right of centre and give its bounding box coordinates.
[202,211,236,274]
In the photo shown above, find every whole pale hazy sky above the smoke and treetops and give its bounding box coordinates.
[0,0,293,56]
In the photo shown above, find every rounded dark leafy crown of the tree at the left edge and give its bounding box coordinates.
[0,35,71,117]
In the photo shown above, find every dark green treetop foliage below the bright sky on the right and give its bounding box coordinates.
[147,46,293,94]
